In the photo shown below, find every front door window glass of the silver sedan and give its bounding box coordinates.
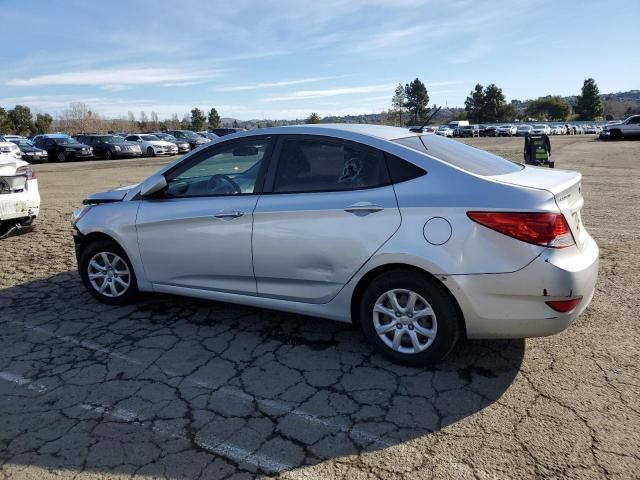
[165,138,269,198]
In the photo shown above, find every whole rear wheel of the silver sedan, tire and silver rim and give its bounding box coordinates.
[360,270,460,366]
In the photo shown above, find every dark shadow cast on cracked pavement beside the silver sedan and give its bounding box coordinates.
[0,272,524,478]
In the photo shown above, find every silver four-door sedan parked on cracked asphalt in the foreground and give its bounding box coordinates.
[72,125,598,365]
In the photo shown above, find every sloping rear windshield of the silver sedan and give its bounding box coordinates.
[393,135,524,177]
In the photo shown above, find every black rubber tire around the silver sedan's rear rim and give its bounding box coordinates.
[360,270,460,367]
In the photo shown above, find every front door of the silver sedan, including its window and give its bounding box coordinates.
[136,137,270,295]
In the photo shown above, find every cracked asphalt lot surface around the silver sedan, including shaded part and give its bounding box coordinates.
[0,136,640,479]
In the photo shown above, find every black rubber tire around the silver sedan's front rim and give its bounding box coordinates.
[78,239,138,305]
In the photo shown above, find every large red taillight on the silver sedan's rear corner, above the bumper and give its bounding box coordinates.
[467,212,575,248]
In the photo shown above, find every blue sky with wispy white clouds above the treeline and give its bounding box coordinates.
[0,0,640,120]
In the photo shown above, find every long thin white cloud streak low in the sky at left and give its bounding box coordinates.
[6,68,221,89]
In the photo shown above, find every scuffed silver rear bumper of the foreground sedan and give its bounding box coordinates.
[445,235,599,338]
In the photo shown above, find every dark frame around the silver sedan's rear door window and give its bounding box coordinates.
[262,134,393,195]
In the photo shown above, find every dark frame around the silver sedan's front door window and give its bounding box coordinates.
[149,135,275,201]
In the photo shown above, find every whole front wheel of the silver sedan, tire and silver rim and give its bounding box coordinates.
[78,240,138,305]
